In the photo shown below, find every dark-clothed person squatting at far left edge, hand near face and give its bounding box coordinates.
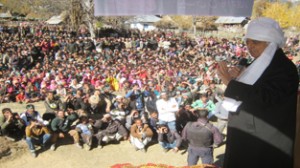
[0,108,25,141]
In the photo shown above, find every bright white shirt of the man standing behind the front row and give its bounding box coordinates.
[156,98,179,122]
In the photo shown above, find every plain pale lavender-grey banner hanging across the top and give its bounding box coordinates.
[94,0,254,16]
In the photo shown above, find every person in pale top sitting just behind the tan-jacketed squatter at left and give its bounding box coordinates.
[20,104,48,126]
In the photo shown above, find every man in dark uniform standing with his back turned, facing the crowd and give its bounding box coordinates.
[182,109,223,166]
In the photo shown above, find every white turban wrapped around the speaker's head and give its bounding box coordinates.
[245,17,286,47]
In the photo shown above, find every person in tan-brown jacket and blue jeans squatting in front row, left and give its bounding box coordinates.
[25,119,51,157]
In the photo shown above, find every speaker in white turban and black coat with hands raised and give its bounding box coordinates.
[217,18,299,168]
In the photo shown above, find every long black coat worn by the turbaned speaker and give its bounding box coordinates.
[224,49,299,168]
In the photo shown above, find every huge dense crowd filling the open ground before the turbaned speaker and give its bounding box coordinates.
[0,23,300,165]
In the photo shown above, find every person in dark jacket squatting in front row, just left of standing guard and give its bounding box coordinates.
[157,125,182,153]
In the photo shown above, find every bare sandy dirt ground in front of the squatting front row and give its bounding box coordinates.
[0,102,225,168]
